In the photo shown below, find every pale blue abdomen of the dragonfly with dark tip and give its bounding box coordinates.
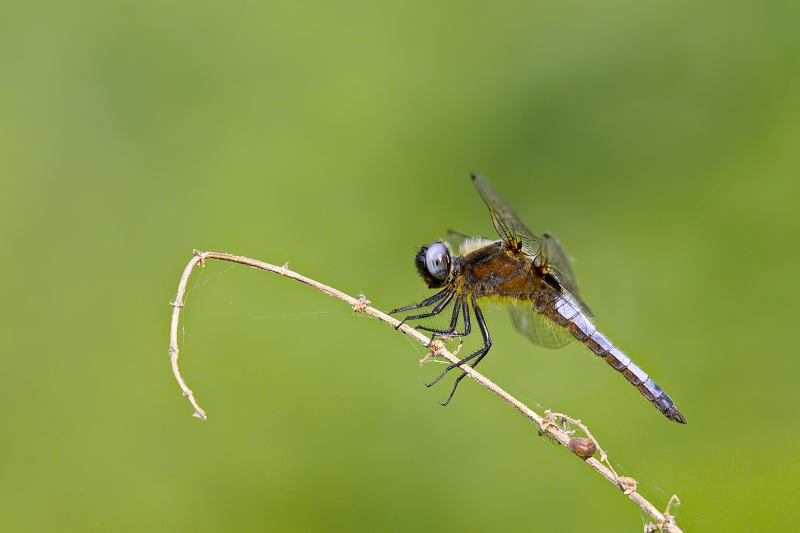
[546,296,686,424]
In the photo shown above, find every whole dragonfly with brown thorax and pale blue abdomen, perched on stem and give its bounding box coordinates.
[389,173,686,424]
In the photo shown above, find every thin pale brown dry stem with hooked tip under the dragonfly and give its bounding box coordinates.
[169,250,681,533]
